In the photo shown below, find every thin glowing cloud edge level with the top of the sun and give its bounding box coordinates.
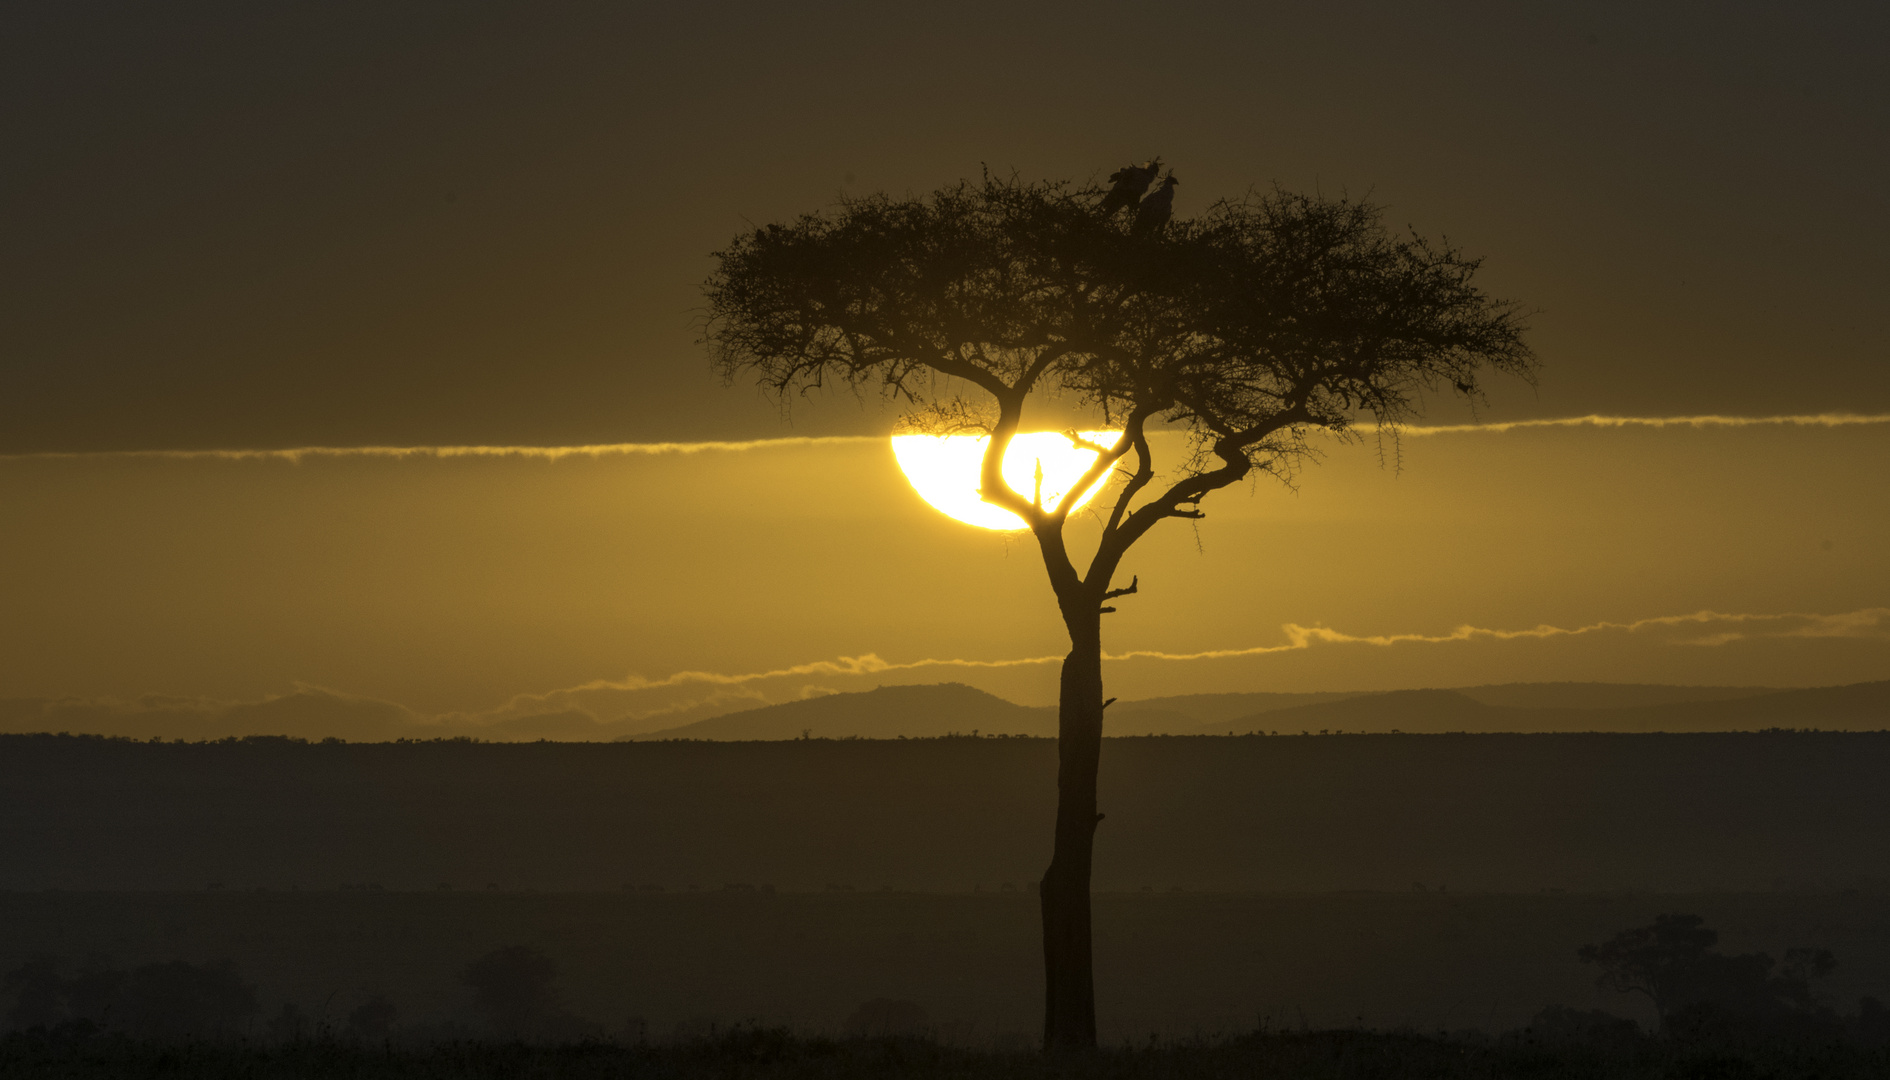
[0,412,1890,463]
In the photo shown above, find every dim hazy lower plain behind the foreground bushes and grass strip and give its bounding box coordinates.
[0,889,1890,1044]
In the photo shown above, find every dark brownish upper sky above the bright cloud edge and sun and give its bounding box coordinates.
[0,0,1890,452]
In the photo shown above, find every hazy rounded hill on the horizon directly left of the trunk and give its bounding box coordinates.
[618,683,1057,741]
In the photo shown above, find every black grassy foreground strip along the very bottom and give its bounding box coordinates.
[0,1029,1890,1080]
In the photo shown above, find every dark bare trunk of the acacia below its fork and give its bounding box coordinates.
[1040,615,1102,1050]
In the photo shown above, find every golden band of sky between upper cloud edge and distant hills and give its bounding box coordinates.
[0,418,1890,730]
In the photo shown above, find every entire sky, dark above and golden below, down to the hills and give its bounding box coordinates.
[0,2,1890,734]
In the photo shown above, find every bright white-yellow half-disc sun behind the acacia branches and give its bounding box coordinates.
[892,431,1123,531]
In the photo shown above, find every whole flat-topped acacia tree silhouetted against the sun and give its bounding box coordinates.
[705,164,1535,1050]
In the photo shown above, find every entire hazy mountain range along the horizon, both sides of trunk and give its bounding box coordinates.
[0,683,1852,741]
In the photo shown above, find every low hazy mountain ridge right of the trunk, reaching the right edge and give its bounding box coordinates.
[1202,681,1890,736]
